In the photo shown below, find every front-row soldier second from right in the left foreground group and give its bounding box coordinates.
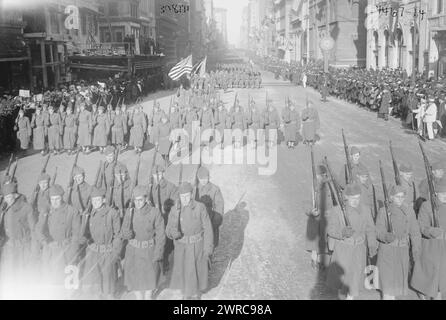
[121,186,166,300]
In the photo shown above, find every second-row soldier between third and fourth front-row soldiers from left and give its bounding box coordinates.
[107,163,132,218]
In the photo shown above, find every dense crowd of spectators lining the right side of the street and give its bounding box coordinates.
[256,58,446,140]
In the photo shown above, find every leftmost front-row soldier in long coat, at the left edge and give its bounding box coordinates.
[0,182,35,299]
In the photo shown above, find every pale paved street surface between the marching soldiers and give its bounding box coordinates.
[2,73,446,300]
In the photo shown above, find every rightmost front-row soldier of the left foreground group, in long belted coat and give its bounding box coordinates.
[166,182,214,299]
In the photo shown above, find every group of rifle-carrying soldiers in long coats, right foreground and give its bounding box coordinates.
[307,141,446,300]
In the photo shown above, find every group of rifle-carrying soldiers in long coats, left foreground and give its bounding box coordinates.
[0,146,224,299]
